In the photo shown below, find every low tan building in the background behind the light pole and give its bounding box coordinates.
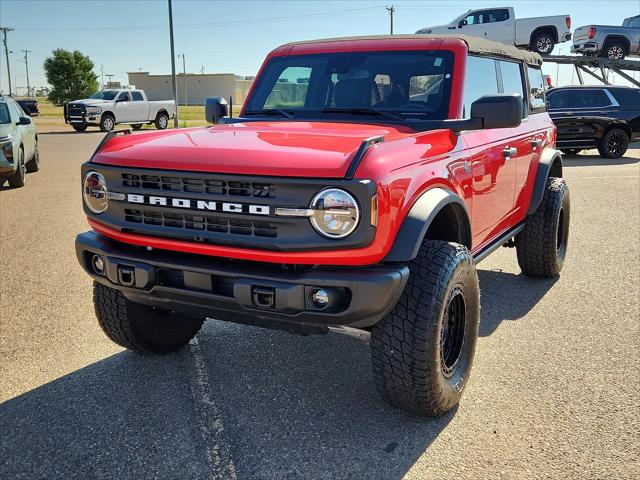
[127,72,253,105]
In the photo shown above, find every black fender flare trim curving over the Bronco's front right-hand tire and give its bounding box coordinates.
[384,187,471,262]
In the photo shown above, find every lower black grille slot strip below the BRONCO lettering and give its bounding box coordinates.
[124,208,278,238]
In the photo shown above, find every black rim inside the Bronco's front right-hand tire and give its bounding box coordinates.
[440,285,467,377]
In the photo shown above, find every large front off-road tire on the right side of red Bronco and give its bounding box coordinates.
[371,240,480,416]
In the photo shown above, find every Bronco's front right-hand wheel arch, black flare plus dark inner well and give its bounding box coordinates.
[384,187,471,262]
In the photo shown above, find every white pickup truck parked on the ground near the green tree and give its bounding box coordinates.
[64,89,176,132]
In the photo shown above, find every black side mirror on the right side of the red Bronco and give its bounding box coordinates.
[471,93,523,128]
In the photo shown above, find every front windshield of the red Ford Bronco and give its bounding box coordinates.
[245,50,453,120]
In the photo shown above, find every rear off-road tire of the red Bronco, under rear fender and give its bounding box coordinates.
[516,177,570,278]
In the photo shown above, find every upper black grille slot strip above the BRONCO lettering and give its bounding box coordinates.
[122,173,275,198]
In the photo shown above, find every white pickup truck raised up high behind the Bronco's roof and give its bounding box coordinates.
[416,7,571,55]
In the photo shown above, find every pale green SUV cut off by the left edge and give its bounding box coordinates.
[0,96,40,188]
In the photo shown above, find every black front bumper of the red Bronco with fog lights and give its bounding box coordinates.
[76,232,409,333]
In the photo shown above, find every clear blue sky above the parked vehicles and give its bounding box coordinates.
[0,0,640,93]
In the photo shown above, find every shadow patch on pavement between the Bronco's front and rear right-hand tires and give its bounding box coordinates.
[478,270,558,337]
